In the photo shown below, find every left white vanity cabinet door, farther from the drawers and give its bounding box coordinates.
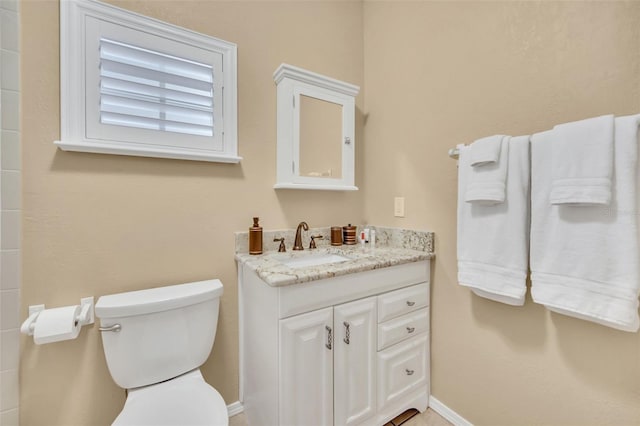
[279,308,333,426]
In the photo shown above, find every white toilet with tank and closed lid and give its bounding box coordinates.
[95,280,229,426]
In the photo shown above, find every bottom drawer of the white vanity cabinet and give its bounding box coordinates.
[378,333,429,411]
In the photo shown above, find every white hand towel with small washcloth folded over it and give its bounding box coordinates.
[462,136,510,205]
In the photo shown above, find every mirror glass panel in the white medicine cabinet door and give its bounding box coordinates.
[300,95,342,179]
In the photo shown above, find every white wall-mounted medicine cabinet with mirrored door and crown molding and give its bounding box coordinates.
[273,64,360,191]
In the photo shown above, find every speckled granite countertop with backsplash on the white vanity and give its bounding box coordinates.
[236,227,434,287]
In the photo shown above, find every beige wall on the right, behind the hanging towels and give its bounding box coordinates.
[362,2,640,425]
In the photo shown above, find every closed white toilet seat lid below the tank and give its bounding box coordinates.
[113,370,229,426]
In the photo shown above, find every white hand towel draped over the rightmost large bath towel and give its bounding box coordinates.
[549,115,614,205]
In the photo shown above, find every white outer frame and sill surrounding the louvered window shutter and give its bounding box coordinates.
[54,0,242,163]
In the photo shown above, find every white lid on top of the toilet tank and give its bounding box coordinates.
[95,280,223,318]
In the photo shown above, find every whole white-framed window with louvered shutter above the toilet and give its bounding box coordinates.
[55,0,241,163]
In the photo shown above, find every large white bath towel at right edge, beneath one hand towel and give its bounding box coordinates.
[531,115,640,331]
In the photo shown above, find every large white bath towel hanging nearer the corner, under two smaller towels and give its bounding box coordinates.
[458,136,529,306]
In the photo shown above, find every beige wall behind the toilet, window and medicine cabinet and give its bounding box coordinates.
[20,0,363,425]
